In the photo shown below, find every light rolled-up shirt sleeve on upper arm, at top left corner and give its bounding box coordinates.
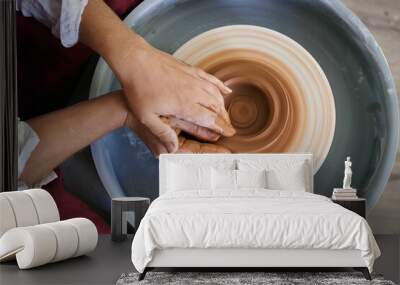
[16,0,88,47]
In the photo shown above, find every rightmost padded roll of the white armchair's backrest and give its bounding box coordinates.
[23,189,60,224]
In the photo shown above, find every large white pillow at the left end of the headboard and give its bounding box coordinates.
[167,163,211,191]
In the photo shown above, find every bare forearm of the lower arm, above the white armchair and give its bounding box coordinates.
[20,93,127,185]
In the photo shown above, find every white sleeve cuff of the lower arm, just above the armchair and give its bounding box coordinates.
[18,118,57,190]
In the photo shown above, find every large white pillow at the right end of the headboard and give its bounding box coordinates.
[267,163,307,191]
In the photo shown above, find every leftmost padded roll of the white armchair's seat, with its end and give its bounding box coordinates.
[0,225,57,269]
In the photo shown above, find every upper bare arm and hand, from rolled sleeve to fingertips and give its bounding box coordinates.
[79,0,235,152]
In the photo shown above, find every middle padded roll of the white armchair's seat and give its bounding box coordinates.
[43,221,79,262]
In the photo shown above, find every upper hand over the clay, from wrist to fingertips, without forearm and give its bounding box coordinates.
[114,37,235,152]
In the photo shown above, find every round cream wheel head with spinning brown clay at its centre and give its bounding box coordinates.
[174,25,335,172]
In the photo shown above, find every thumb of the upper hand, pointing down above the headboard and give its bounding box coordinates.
[141,114,179,153]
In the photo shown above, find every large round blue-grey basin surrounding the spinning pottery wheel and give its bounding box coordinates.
[90,0,399,209]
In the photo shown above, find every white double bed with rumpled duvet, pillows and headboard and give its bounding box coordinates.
[132,154,380,278]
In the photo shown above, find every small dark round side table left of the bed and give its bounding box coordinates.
[111,197,150,241]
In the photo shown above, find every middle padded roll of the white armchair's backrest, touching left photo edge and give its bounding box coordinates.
[1,191,39,227]
